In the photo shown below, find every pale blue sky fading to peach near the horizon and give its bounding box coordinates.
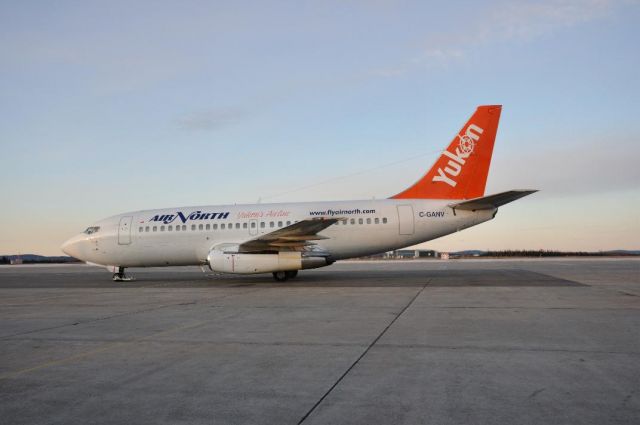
[0,0,640,255]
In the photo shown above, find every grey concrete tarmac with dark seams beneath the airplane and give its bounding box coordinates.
[0,258,640,425]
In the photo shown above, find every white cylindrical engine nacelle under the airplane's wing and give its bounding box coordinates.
[207,249,329,274]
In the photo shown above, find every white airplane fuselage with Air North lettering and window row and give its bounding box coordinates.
[63,199,497,267]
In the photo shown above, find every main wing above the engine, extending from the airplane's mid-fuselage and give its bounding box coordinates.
[238,218,342,252]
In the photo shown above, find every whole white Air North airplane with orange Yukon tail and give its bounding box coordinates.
[62,105,536,281]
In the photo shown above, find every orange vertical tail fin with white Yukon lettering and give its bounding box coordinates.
[391,105,502,199]
